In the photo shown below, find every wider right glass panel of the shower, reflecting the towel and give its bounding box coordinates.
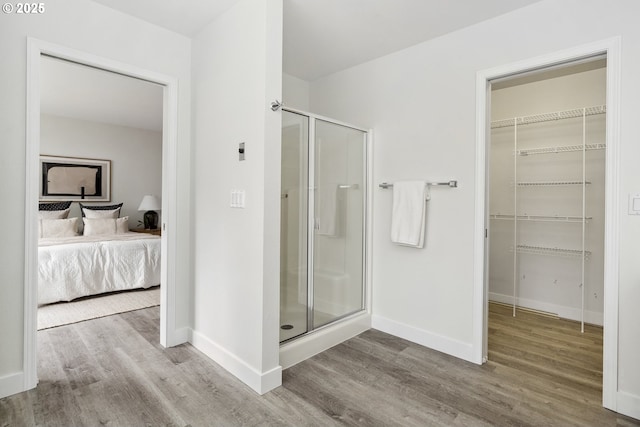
[313,120,365,328]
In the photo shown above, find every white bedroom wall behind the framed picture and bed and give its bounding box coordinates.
[40,115,162,228]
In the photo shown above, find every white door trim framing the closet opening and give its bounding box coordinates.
[473,37,621,411]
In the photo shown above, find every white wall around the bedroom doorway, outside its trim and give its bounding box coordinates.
[0,0,191,402]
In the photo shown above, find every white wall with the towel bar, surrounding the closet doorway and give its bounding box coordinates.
[310,0,640,417]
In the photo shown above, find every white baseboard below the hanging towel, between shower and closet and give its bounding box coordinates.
[371,315,477,363]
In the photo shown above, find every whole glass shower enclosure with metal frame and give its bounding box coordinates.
[280,109,367,343]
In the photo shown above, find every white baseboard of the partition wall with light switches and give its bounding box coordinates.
[189,330,282,394]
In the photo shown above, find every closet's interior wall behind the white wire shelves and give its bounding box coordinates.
[489,68,606,325]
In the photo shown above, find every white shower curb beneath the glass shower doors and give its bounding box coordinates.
[280,313,371,369]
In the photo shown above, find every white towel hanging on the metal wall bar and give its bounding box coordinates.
[391,181,427,248]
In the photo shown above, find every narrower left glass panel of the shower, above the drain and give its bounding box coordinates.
[280,111,309,342]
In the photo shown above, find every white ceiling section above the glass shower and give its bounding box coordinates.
[283,0,539,81]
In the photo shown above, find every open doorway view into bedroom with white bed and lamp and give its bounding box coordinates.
[37,55,163,330]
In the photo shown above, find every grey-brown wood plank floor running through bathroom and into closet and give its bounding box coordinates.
[0,306,640,427]
